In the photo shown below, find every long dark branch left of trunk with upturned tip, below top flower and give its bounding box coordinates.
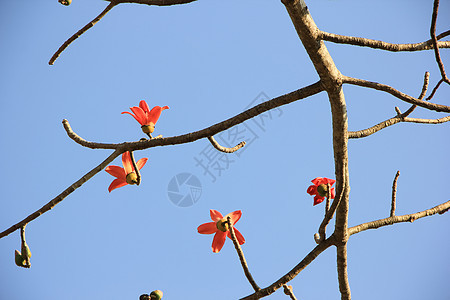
[63,81,324,152]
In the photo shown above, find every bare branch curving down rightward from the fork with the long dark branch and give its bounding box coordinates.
[342,75,450,112]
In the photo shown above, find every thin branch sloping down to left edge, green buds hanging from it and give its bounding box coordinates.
[0,150,122,239]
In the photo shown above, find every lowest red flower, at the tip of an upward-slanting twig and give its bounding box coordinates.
[197,209,245,253]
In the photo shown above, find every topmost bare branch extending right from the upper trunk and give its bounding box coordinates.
[319,30,450,52]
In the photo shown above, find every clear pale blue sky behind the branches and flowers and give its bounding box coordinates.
[0,0,450,300]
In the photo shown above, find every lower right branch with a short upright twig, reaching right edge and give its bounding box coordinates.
[348,201,450,235]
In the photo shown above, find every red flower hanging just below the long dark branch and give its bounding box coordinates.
[105,151,148,193]
